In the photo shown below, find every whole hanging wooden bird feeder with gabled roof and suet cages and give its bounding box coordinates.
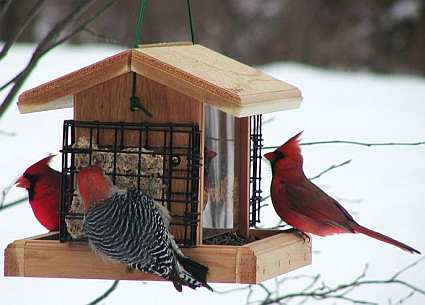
[5,43,311,284]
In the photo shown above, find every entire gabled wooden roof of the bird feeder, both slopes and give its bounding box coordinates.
[18,43,302,117]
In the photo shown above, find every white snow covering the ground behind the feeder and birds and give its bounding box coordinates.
[0,45,425,305]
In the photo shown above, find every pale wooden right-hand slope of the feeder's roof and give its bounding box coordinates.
[135,45,296,99]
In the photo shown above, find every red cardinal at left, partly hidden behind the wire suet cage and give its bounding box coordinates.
[16,156,61,231]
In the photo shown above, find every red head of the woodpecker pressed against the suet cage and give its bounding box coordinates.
[77,165,112,211]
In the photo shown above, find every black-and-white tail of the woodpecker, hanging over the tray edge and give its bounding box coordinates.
[171,255,213,291]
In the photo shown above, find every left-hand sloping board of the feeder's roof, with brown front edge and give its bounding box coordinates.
[18,50,131,113]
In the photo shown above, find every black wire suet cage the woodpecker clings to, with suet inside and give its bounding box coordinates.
[59,120,200,247]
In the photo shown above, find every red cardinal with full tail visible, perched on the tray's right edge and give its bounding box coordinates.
[264,132,420,254]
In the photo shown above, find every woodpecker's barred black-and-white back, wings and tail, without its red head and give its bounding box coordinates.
[84,189,211,291]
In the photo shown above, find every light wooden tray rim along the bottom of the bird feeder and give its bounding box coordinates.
[4,230,311,284]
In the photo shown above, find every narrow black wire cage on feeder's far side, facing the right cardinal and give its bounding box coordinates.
[249,114,263,227]
